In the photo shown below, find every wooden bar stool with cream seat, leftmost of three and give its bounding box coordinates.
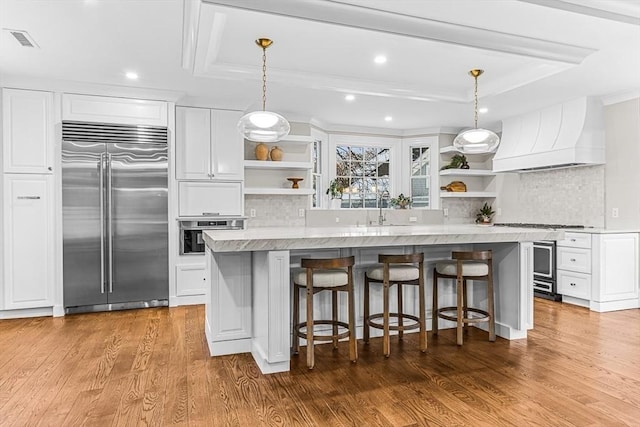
[293,256,358,369]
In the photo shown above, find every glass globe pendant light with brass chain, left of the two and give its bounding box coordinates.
[238,39,290,142]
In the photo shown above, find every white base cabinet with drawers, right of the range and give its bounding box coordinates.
[557,232,640,311]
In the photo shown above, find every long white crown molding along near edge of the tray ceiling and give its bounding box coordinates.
[201,0,595,64]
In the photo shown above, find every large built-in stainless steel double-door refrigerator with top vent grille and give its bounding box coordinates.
[62,122,169,313]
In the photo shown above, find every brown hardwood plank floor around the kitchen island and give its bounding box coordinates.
[0,300,640,427]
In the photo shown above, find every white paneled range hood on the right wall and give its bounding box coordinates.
[493,97,605,172]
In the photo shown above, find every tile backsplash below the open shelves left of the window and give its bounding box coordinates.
[244,194,309,228]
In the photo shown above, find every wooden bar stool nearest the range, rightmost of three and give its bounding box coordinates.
[432,251,496,345]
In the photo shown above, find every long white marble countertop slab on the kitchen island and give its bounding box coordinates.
[202,225,564,252]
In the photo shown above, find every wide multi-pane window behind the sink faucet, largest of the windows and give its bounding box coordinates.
[336,145,391,208]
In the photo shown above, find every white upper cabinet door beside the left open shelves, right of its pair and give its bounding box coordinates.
[211,110,244,180]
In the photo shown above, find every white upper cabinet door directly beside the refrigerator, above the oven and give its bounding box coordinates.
[176,107,212,180]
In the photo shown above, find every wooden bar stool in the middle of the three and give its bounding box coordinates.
[363,253,427,357]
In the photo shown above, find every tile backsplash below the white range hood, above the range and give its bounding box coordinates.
[495,165,605,227]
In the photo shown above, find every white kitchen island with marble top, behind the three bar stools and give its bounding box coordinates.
[203,225,564,373]
